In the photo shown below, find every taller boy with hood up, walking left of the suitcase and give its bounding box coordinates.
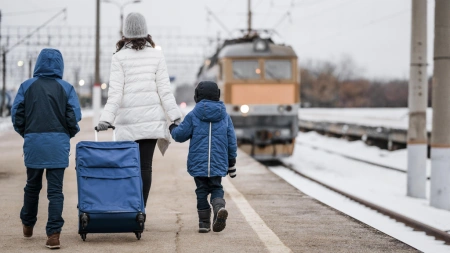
[11,48,81,249]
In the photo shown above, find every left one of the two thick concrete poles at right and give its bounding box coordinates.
[407,0,428,199]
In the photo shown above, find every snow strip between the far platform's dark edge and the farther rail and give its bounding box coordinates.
[296,132,431,176]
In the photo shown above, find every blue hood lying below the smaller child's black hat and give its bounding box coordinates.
[193,99,227,122]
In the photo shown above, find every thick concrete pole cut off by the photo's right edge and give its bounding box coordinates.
[430,0,450,210]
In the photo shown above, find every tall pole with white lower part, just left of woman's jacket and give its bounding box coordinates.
[92,0,101,126]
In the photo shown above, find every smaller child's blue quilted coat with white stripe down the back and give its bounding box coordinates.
[172,99,237,177]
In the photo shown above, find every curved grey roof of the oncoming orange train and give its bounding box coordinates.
[219,42,297,58]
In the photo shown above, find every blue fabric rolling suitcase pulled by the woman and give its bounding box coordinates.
[76,127,145,241]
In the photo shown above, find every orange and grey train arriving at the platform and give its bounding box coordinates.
[197,33,300,160]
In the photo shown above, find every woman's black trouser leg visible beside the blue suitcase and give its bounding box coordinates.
[136,139,157,206]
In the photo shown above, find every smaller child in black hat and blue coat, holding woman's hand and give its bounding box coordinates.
[170,81,237,233]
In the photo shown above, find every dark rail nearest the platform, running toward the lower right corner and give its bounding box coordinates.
[272,161,450,245]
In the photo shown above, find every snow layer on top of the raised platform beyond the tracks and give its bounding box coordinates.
[298,108,433,131]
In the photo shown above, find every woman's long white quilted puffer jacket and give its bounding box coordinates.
[100,44,181,153]
